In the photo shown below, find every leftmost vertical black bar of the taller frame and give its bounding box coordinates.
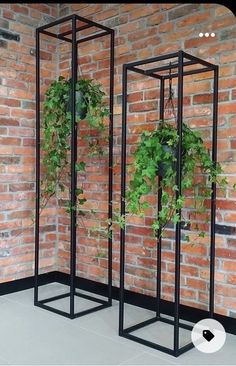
[34,29,40,304]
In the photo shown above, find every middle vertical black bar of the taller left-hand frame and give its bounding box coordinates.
[70,15,77,317]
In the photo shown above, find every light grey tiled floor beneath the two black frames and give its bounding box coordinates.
[0,284,236,365]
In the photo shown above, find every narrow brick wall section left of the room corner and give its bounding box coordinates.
[0,4,58,282]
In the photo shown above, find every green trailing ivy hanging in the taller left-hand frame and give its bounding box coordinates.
[41,76,109,216]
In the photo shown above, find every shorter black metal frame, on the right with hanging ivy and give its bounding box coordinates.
[119,50,218,357]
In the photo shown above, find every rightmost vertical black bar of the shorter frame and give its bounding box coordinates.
[209,66,219,318]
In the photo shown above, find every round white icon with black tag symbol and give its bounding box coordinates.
[191,318,226,353]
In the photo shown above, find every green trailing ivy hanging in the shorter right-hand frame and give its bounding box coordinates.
[126,121,227,240]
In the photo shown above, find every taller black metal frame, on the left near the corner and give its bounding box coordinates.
[34,14,114,319]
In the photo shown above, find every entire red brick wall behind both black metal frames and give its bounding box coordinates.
[0,4,236,316]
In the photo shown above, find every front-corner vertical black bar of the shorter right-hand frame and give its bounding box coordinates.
[174,51,183,354]
